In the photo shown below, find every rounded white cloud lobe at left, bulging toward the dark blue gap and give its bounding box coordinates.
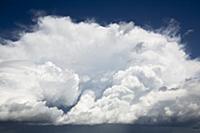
[0,60,79,122]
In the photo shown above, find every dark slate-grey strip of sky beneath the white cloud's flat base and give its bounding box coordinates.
[0,122,200,133]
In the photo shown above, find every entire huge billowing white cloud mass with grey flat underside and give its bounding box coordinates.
[0,16,200,124]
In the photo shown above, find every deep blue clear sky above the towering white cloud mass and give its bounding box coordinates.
[0,0,200,57]
